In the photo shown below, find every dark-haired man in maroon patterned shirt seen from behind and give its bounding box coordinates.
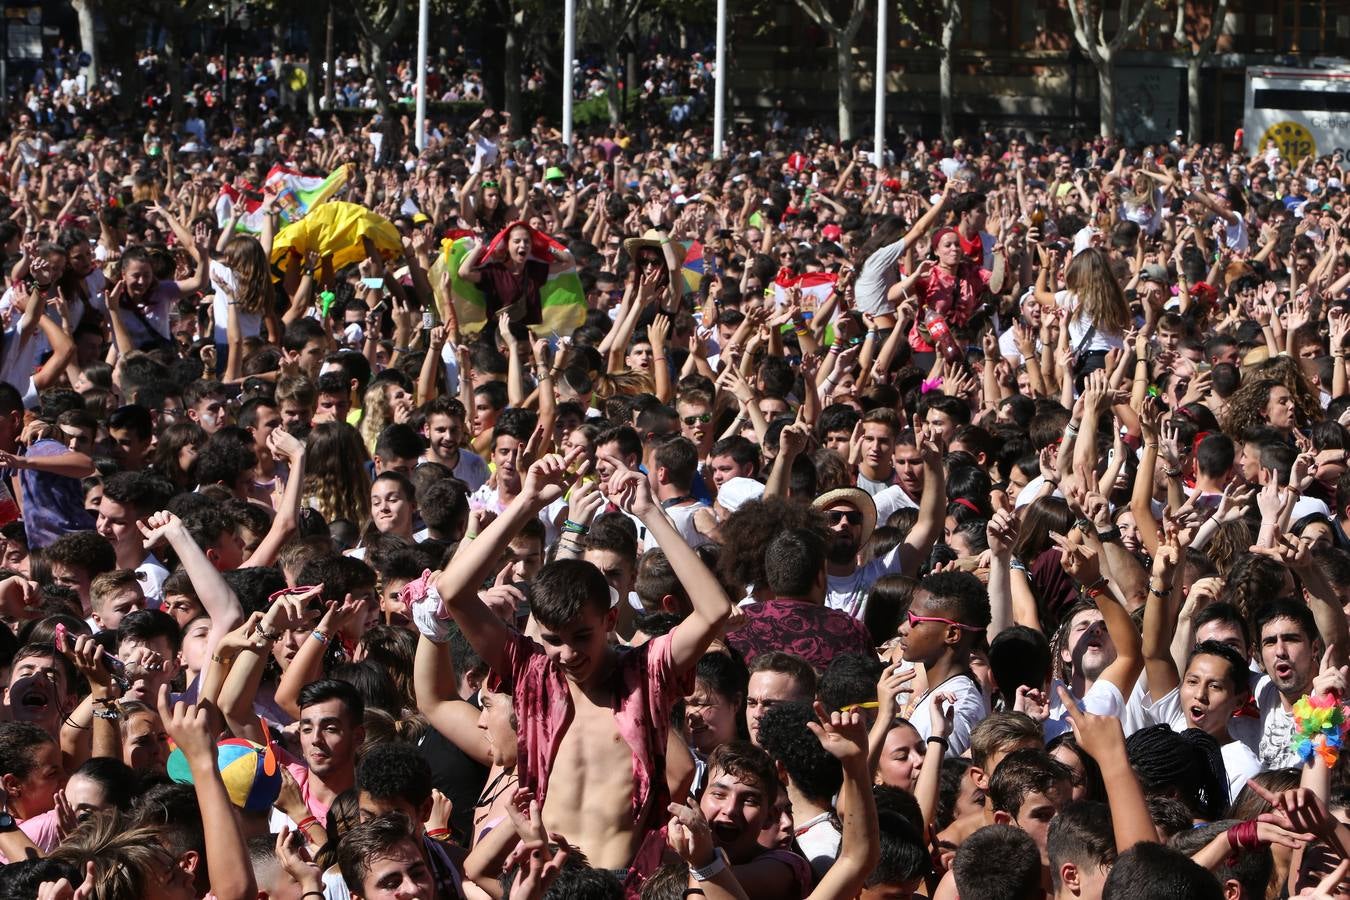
[726,528,872,671]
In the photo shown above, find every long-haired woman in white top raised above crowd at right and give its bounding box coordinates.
[1035,247,1133,381]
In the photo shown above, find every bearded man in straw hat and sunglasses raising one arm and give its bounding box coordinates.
[811,434,946,618]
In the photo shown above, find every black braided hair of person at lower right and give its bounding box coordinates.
[1125,725,1229,822]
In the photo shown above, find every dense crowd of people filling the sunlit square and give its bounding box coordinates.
[0,45,1350,900]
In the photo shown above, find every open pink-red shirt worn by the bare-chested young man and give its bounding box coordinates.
[498,633,694,896]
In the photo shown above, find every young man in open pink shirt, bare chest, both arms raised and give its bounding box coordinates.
[426,453,732,884]
